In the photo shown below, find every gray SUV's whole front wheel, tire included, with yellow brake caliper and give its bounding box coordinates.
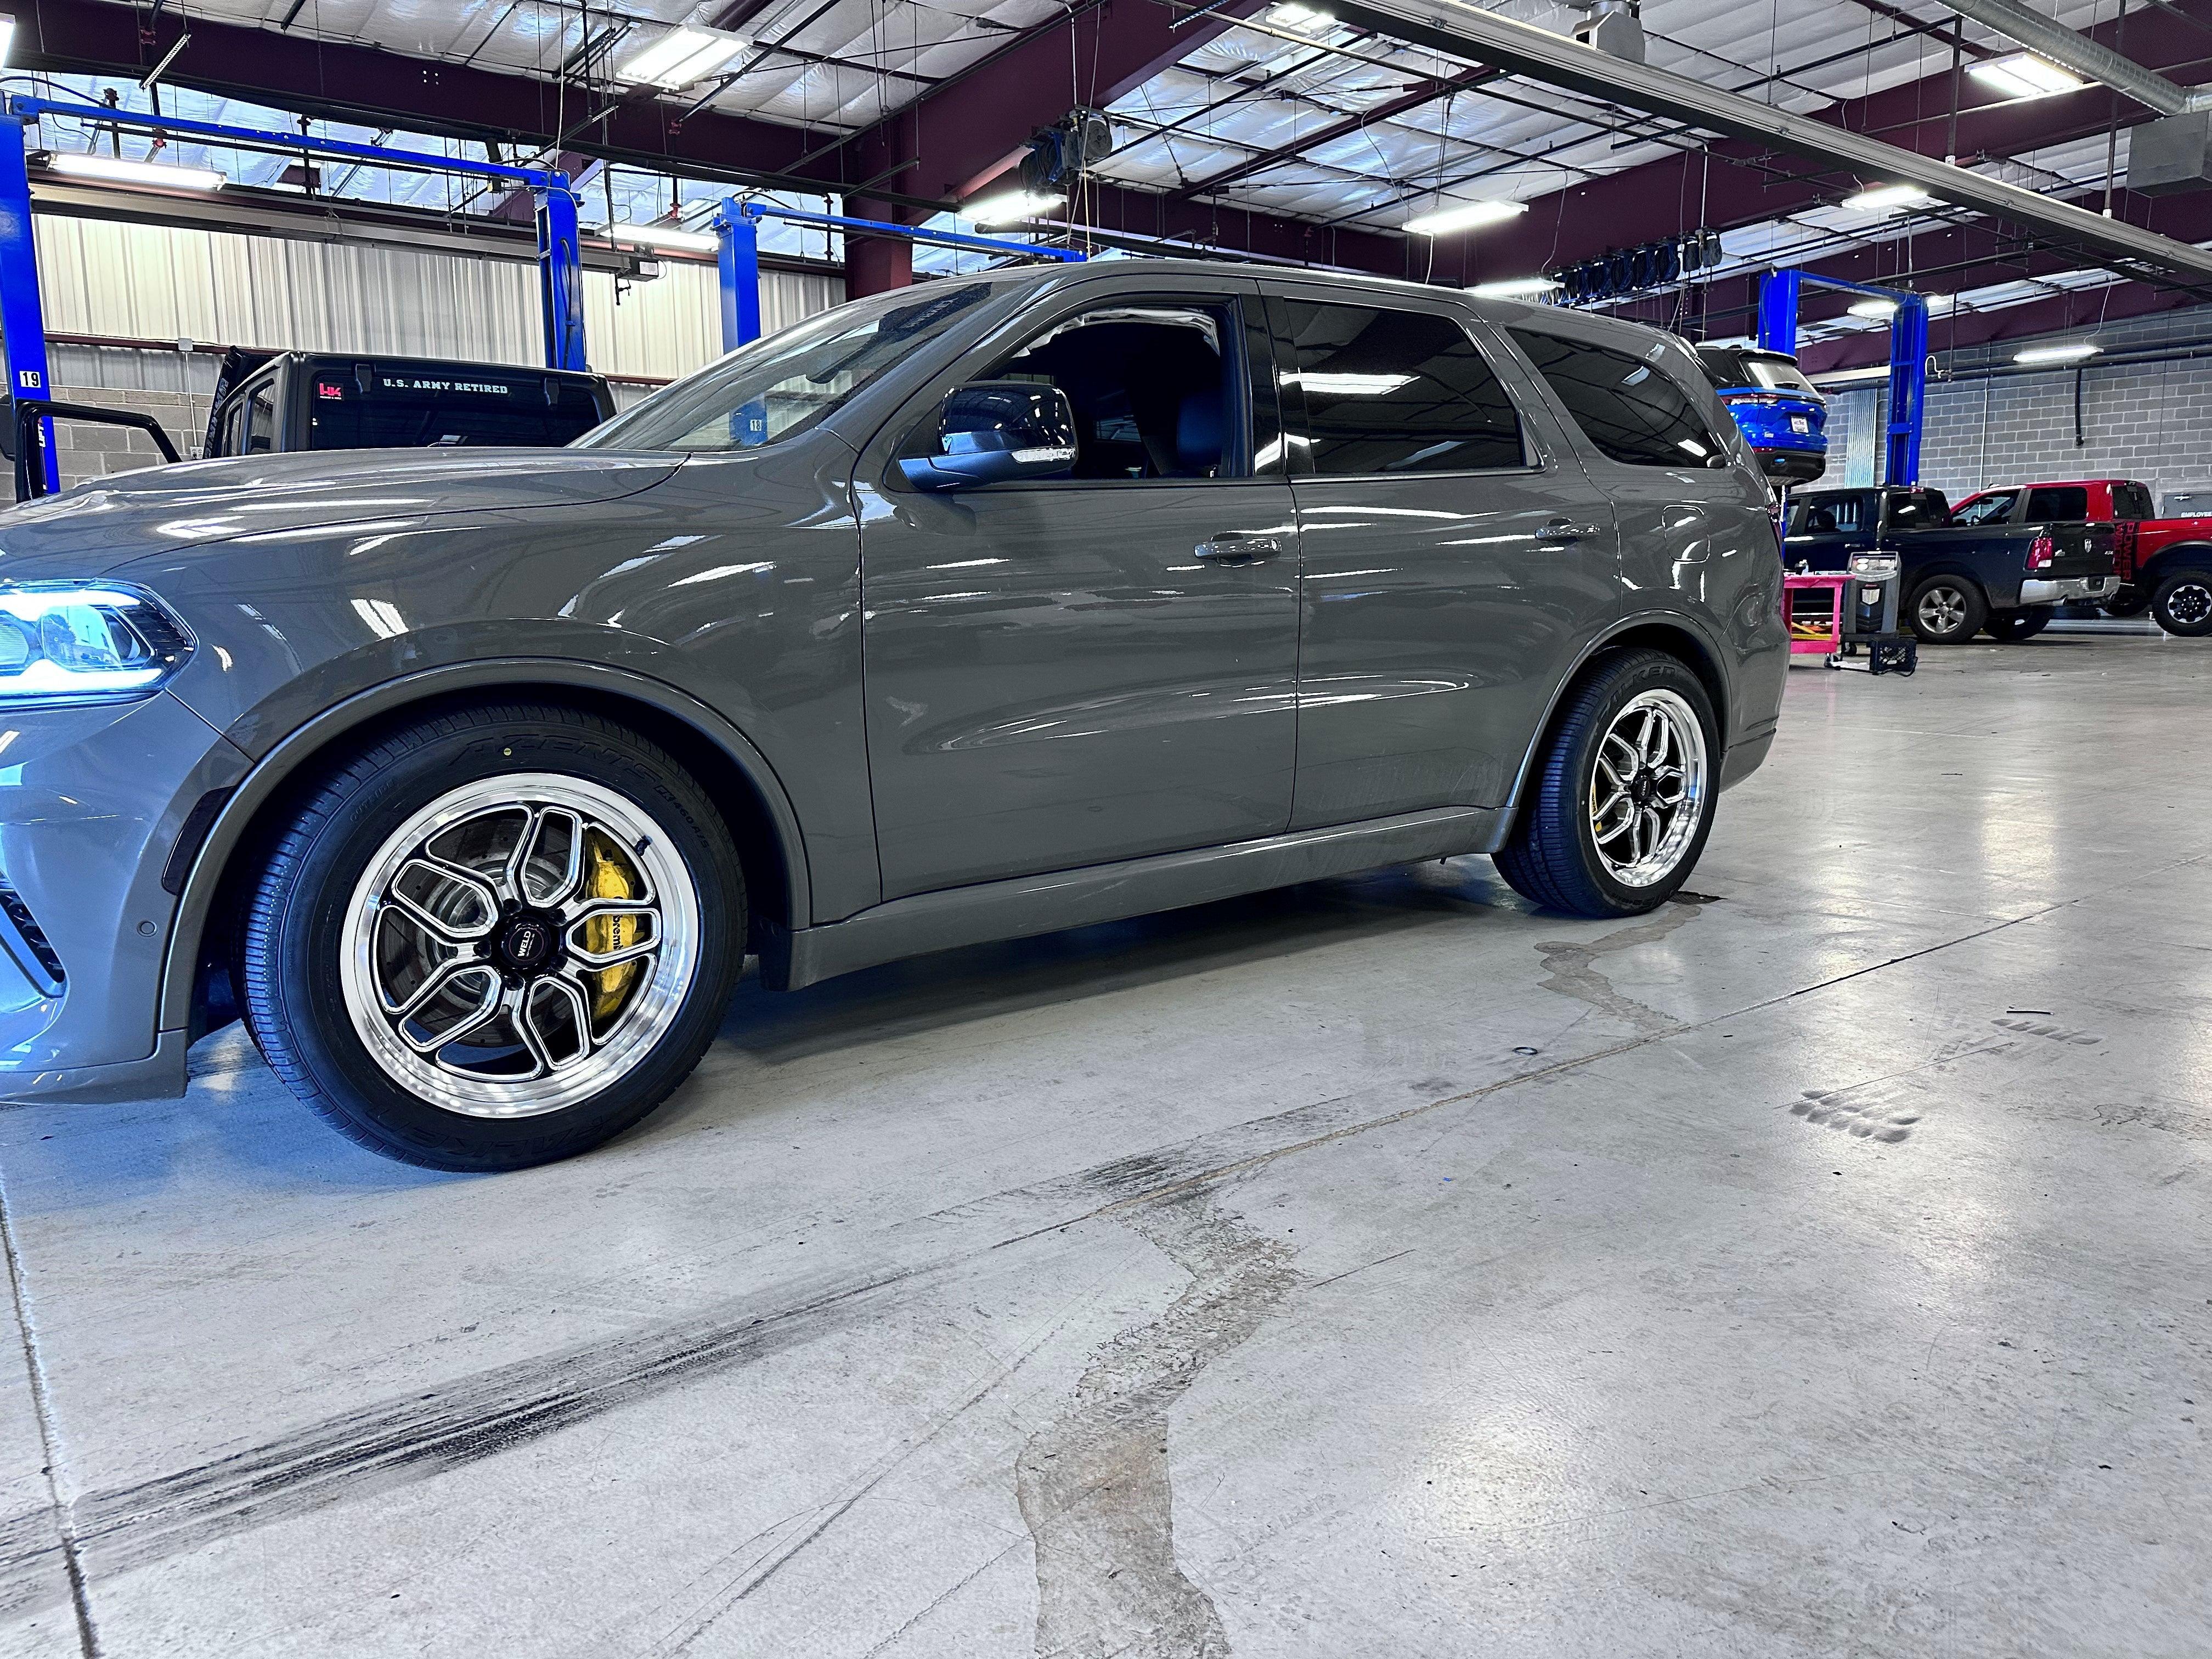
[239,706,746,1170]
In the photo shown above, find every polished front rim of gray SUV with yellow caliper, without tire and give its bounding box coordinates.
[338,772,699,1117]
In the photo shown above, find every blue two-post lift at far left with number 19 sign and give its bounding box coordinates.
[0,95,586,489]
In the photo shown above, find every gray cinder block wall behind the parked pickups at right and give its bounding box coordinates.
[1822,307,2212,500]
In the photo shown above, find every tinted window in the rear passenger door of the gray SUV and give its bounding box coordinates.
[1283,298,1528,478]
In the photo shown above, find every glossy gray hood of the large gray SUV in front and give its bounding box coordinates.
[0,449,681,582]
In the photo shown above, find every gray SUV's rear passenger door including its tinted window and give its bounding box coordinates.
[1269,296,1619,827]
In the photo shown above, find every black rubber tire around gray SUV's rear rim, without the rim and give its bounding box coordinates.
[1496,650,1721,918]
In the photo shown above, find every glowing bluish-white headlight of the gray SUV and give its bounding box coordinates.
[0,582,193,706]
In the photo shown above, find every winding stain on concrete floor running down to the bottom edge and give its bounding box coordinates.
[1015,1192,1299,1659]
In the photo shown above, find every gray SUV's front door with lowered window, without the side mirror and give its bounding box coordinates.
[858,276,1299,898]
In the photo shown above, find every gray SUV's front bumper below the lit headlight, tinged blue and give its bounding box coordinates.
[0,692,248,1099]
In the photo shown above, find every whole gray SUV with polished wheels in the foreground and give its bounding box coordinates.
[0,261,1787,1170]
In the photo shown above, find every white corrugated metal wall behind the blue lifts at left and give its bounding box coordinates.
[33,215,845,381]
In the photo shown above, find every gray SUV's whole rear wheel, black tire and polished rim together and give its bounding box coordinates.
[1496,650,1721,918]
